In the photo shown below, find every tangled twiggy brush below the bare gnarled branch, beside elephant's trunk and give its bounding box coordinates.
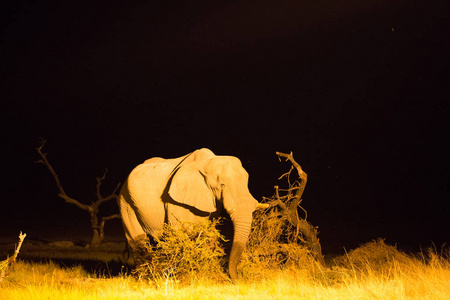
[240,189,321,279]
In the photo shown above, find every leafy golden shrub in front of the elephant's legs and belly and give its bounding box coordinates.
[135,220,227,282]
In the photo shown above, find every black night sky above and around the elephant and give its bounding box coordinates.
[0,0,450,252]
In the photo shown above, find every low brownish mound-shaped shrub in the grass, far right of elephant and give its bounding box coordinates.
[333,238,413,273]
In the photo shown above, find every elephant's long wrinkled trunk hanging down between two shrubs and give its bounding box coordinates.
[228,210,252,280]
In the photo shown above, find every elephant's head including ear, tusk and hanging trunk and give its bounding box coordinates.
[169,156,265,280]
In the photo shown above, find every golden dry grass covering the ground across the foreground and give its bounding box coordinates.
[0,240,450,300]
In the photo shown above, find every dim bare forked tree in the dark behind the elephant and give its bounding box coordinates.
[36,139,120,248]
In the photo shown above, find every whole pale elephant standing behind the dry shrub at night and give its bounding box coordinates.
[118,148,268,280]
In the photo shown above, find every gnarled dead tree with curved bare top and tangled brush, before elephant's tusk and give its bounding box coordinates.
[241,152,325,271]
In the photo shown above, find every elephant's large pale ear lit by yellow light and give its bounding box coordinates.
[169,165,217,212]
